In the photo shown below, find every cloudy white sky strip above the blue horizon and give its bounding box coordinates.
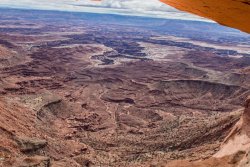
[0,0,208,21]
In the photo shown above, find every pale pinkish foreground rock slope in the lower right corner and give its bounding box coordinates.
[157,97,250,167]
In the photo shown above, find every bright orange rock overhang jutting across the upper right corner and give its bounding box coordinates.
[161,0,250,33]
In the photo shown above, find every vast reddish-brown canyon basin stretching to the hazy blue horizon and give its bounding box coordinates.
[0,9,250,167]
